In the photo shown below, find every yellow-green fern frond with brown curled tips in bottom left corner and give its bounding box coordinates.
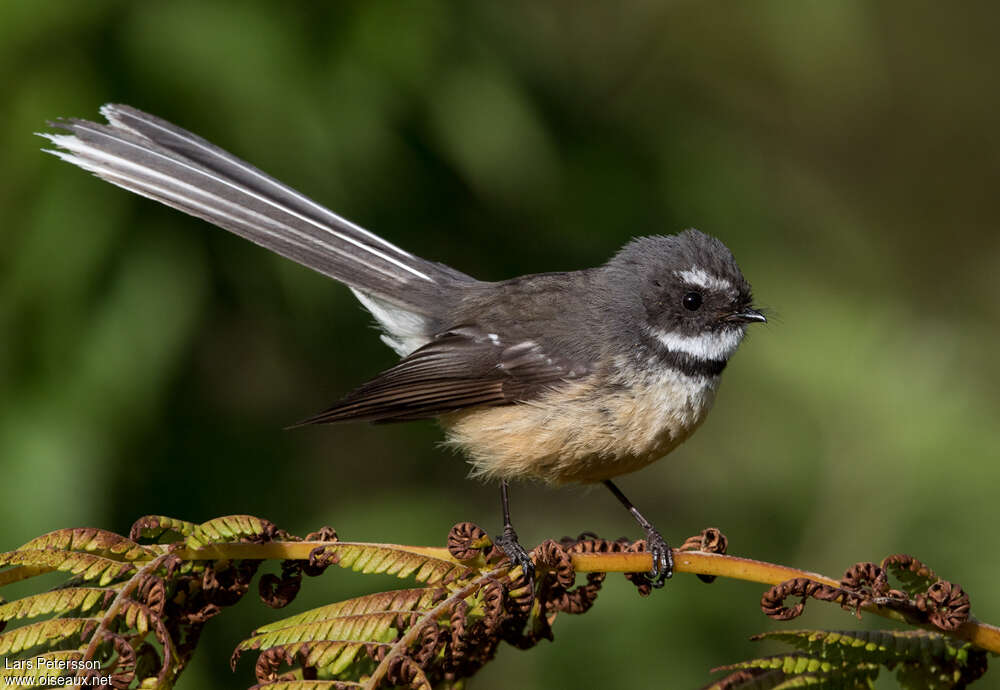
[0,516,274,687]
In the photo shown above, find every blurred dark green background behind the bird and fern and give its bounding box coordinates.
[0,0,1000,690]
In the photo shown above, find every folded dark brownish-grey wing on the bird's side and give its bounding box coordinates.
[296,327,586,426]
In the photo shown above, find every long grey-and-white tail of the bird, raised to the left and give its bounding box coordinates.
[41,105,472,312]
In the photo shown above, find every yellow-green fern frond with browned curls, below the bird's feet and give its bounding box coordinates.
[232,543,508,688]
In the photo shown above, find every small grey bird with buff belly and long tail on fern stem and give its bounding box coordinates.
[39,104,767,587]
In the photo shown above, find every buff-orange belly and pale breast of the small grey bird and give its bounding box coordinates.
[441,370,718,484]
